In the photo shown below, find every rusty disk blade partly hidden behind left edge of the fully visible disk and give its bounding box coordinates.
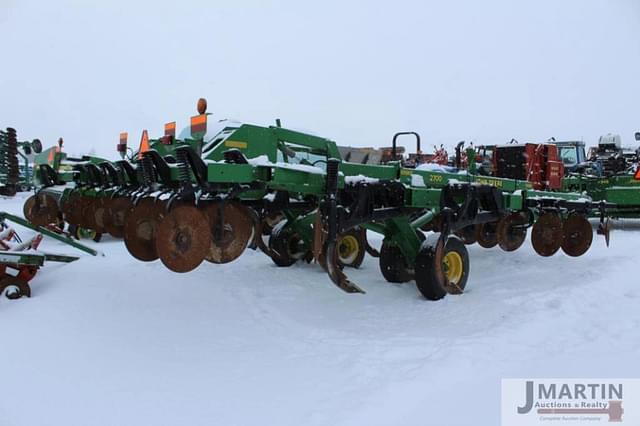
[124,198,164,262]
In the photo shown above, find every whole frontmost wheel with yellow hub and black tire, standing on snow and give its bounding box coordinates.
[415,233,469,300]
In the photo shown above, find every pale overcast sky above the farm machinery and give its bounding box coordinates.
[0,0,640,158]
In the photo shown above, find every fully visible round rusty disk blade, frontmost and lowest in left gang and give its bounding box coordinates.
[156,205,211,272]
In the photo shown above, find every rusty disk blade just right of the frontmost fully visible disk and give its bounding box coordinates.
[204,201,253,263]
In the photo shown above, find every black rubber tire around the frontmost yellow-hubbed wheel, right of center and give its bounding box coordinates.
[415,234,469,300]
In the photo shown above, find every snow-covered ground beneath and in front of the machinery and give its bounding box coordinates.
[0,196,640,426]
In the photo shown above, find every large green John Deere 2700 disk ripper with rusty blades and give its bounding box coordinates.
[22,101,624,300]
